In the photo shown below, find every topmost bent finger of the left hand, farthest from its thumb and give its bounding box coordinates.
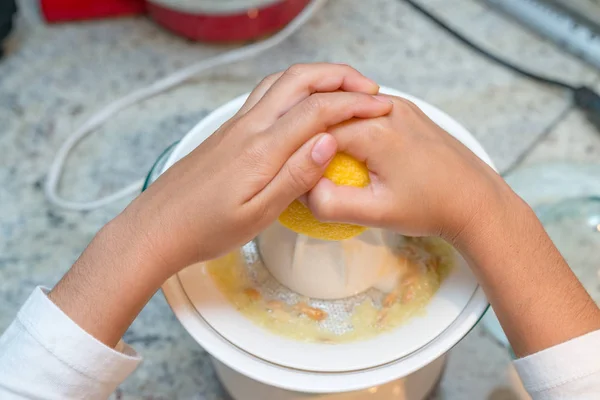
[250,63,379,123]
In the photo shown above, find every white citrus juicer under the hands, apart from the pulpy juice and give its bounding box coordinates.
[146,88,492,400]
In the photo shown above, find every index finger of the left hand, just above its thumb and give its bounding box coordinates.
[265,92,392,166]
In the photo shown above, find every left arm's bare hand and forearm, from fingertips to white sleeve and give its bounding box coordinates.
[49,64,392,347]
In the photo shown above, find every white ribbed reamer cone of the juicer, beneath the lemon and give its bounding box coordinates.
[257,222,401,300]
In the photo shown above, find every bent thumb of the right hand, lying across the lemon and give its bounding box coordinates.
[307,178,384,226]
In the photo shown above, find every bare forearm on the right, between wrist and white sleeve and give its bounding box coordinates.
[457,189,600,356]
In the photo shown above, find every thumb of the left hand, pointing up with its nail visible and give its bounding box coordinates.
[253,133,337,217]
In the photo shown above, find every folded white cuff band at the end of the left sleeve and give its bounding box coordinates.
[17,287,141,383]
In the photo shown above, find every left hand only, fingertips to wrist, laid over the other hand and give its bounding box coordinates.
[125,64,392,273]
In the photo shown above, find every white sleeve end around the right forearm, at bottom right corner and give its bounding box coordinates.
[514,330,600,399]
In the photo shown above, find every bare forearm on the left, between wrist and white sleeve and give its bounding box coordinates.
[49,214,168,347]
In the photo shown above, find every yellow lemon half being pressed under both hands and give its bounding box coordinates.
[279,153,370,240]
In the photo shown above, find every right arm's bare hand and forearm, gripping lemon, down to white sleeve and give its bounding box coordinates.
[307,97,600,357]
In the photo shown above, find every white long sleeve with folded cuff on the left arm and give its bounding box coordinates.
[0,288,141,400]
